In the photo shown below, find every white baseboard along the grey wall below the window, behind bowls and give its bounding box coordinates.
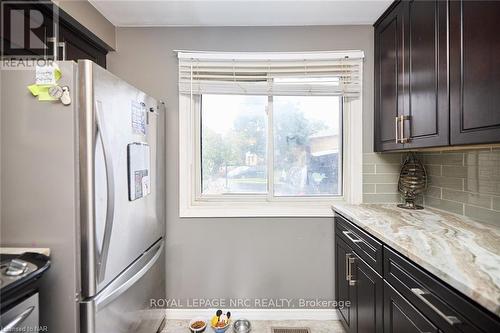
[165,309,338,320]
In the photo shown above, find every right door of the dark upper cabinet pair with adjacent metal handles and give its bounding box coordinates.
[400,0,449,148]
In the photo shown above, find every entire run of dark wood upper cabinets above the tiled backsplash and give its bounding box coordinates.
[375,0,500,151]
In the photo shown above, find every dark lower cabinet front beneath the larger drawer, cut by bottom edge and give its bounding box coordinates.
[384,281,439,333]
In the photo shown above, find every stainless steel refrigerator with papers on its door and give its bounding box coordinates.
[0,60,165,333]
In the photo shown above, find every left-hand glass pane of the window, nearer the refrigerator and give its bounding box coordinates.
[201,95,268,195]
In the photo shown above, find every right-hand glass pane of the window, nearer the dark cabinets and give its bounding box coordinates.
[272,96,342,196]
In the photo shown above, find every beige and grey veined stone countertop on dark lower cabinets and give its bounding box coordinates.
[332,204,500,316]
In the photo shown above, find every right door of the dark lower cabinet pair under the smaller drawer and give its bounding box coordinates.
[352,253,384,333]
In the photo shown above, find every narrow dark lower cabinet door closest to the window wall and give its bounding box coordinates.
[335,235,356,333]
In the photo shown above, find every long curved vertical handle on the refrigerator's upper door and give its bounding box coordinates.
[95,101,115,282]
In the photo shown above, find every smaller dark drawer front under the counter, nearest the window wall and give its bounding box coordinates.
[335,213,383,275]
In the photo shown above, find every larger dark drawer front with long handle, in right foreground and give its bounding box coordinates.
[384,246,500,333]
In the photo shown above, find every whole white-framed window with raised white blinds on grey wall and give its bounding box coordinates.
[179,49,361,217]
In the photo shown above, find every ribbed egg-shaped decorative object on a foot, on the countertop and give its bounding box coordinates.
[398,153,427,209]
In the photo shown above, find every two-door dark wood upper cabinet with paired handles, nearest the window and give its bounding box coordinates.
[375,0,449,151]
